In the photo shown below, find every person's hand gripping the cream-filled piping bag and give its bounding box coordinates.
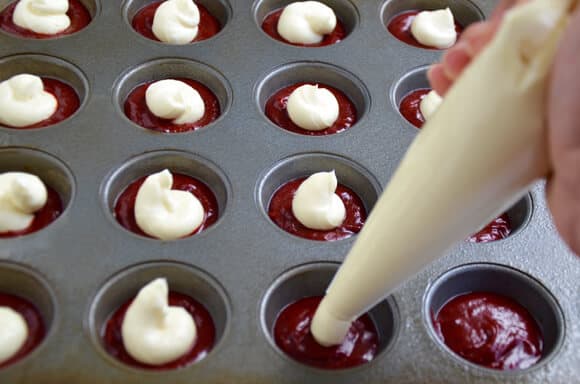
[428,0,580,255]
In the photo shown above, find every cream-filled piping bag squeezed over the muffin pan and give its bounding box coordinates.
[311,0,578,346]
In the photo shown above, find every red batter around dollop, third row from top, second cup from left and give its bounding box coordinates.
[115,173,218,237]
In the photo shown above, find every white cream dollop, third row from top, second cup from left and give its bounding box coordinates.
[135,169,205,240]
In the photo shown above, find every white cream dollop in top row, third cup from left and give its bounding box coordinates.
[277,1,336,44]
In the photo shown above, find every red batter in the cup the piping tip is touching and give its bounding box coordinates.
[274,297,379,369]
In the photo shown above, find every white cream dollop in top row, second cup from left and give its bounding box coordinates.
[152,0,200,44]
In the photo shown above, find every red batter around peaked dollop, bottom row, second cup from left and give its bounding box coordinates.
[103,292,215,370]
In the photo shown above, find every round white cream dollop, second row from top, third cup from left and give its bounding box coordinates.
[286,84,339,131]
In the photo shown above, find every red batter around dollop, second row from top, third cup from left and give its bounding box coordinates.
[266,83,357,136]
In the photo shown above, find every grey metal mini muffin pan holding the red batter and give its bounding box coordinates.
[0,0,580,384]
